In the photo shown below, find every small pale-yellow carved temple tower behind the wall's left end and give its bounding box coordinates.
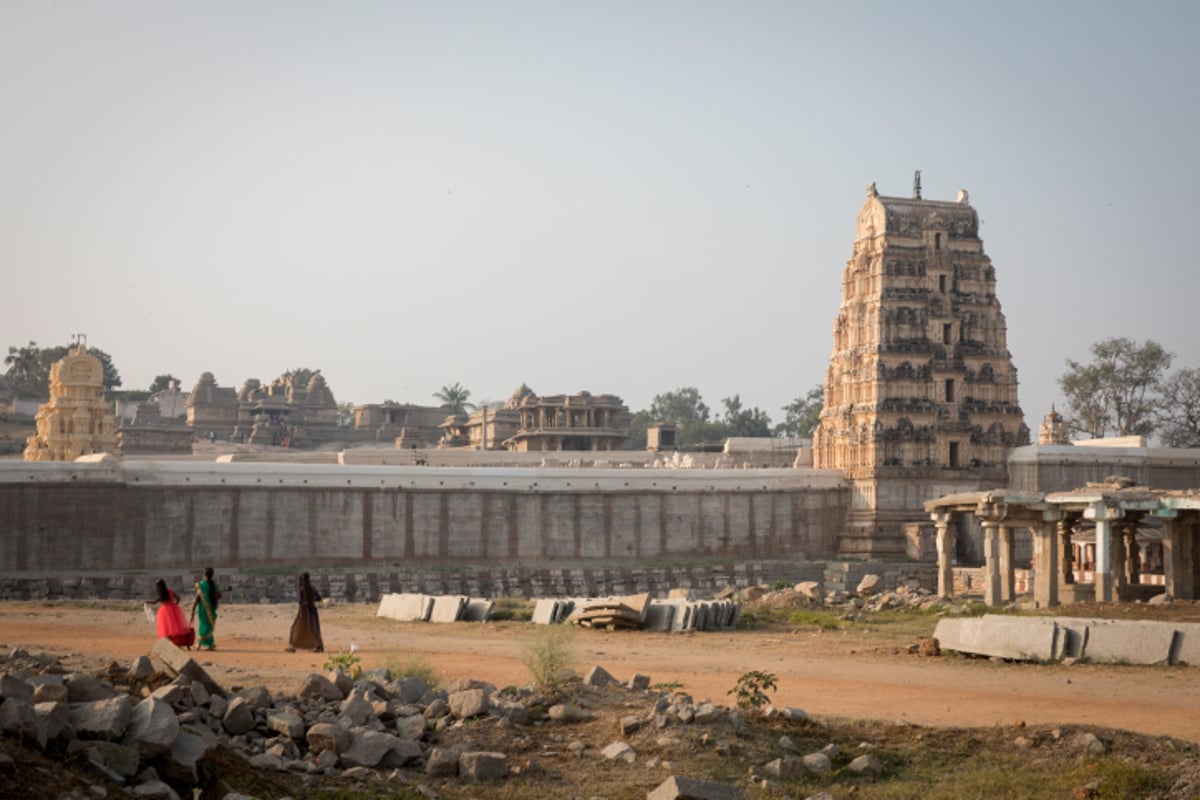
[25,341,118,461]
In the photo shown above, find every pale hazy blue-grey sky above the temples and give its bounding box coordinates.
[0,0,1200,431]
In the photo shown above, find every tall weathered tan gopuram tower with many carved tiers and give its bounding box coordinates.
[812,173,1030,557]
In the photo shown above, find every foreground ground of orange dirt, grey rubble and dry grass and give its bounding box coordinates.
[0,593,1200,800]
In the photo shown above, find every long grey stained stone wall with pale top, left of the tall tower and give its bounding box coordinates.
[0,458,848,576]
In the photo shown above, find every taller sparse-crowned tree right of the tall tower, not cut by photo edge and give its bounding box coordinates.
[1058,337,1174,438]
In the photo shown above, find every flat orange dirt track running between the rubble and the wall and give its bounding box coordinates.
[0,602,1200,742]
